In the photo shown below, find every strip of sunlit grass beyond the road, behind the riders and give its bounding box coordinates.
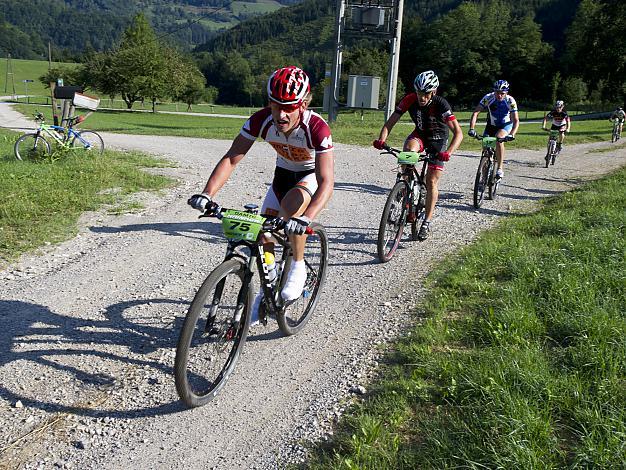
[9,104,612,150]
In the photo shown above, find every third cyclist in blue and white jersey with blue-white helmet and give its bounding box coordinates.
[468,80,519,178]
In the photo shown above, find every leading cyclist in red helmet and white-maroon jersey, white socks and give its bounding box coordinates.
[189,66,334,305]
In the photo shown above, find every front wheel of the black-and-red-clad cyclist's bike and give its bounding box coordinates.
[377,181,408,263]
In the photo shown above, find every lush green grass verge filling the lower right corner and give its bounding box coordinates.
[308,169,626,469]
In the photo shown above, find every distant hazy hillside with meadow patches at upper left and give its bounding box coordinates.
[0,0,299,59]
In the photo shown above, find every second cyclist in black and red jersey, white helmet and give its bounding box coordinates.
[372,70,463,240]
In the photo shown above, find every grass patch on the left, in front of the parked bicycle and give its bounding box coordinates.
[0,130,173,267]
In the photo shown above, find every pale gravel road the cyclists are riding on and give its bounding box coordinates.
[0,105,626,469]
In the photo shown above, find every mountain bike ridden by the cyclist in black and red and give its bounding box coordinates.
[377,145,434,263]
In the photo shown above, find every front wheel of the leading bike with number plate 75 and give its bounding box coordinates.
[174,259,253,407]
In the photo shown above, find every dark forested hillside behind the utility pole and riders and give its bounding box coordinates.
[196,0,626,107]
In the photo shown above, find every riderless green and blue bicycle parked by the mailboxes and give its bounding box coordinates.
[13,113,104,160]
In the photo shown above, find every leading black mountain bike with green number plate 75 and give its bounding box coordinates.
[174,204,328,407]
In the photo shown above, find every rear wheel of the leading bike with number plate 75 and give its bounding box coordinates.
[276,222,328,336]
